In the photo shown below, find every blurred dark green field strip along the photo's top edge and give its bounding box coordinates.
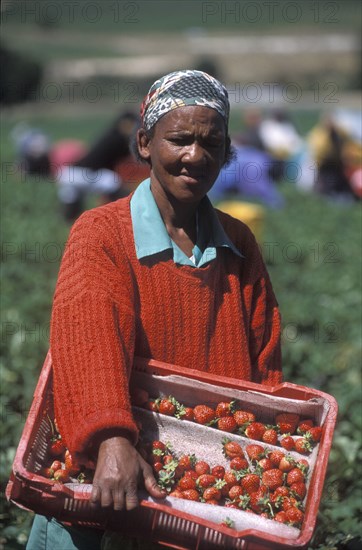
[2,0,359,34]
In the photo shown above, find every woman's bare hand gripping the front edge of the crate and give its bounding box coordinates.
[90,436,166,510]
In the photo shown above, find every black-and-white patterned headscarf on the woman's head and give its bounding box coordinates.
[141,70,230,130]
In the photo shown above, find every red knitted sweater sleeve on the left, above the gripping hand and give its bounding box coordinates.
[50,210,138,458]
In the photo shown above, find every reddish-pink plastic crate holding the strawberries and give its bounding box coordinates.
[6,354,337,550]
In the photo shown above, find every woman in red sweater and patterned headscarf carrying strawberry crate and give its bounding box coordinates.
[29,70,281,549]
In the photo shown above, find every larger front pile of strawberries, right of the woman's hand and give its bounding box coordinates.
[147,438,309,528]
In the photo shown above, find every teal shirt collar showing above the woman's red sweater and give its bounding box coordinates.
[131,179,243,267]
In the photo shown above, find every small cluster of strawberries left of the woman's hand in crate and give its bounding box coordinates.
[40,414,94,483]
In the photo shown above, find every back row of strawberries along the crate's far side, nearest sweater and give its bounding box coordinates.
[132,388,322,454]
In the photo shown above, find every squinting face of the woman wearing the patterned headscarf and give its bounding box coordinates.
[138,106,227,203]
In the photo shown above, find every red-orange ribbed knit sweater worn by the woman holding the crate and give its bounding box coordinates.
[51,197,282,455]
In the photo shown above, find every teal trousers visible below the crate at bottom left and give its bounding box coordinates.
[26,515,165,550]
